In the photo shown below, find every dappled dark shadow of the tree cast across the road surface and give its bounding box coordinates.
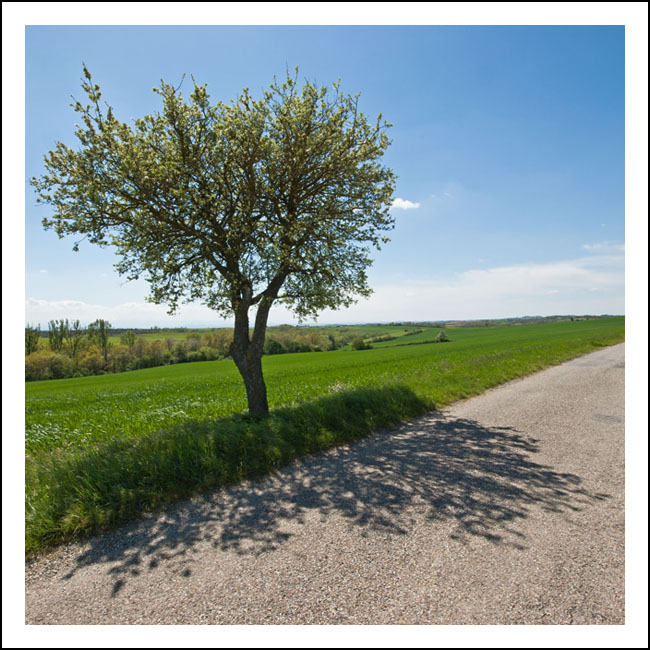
[59,413,608,595]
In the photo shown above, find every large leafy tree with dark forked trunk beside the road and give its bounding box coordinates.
[32,66,395,414]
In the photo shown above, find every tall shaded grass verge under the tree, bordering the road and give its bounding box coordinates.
[26,385,434,557]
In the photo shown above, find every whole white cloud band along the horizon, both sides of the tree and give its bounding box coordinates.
[26,252,625,327]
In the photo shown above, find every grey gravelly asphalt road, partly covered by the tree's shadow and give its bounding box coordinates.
[26,344,625,625]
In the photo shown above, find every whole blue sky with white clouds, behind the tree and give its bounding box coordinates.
[25,25,625,327]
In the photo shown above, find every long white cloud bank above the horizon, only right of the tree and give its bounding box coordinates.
[298,254,625,323]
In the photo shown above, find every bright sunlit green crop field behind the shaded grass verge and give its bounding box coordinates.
[25,317,624,453]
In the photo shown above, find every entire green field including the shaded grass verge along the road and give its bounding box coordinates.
[25,317,624,552]
